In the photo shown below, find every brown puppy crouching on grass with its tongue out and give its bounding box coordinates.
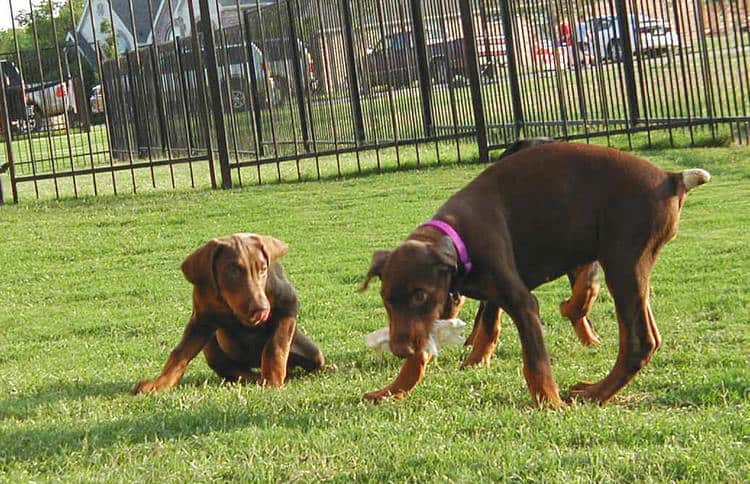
[131,233,324,394]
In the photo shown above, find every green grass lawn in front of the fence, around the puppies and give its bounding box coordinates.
[0,147,750,482]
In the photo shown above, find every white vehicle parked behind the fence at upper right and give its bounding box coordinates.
[587,14,680,62]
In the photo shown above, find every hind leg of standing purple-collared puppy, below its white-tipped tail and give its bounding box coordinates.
[569,255,661,403]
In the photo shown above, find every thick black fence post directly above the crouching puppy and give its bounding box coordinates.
[198,0,232,188]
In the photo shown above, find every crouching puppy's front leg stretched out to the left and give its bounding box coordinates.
[130,316,215,395]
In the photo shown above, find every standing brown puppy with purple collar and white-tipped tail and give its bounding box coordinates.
[363,142,710,407]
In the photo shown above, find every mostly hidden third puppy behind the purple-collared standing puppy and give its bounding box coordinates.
[464,137,600,350]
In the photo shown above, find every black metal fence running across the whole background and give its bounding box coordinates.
[0,0,750,200]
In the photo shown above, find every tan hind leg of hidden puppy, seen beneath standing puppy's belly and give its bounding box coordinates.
[560,262,600,346]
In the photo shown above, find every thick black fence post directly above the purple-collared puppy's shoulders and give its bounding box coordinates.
[458,0,490,163]
